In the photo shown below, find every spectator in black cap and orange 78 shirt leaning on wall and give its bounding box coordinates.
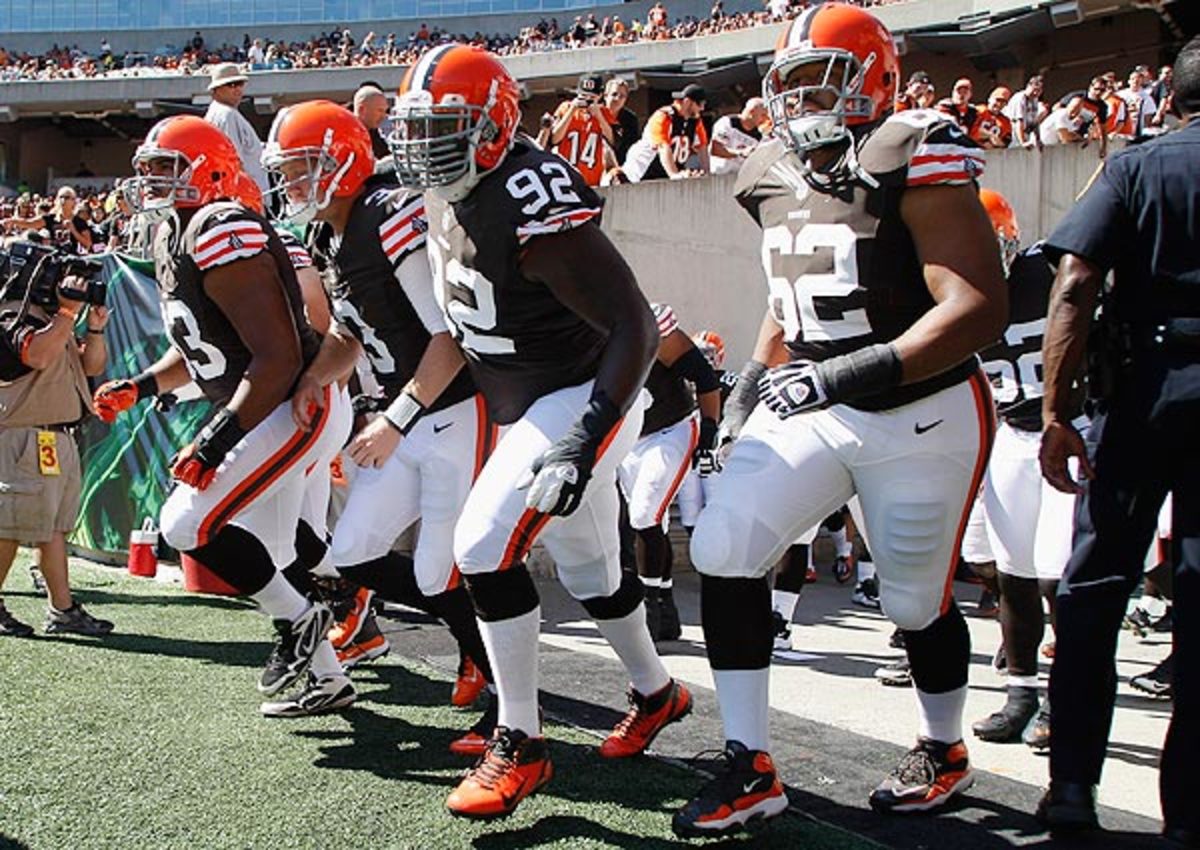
[622,83,709,182]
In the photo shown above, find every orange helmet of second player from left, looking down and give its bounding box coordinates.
[263,101,374,223]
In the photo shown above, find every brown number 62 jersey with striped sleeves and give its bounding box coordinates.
[734,109,998,411]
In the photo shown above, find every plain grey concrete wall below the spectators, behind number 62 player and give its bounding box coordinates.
[602,148,1099,369]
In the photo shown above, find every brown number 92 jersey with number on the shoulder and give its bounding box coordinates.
[425,137,606,425]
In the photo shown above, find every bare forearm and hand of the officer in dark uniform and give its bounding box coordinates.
[1040,253,1104,493]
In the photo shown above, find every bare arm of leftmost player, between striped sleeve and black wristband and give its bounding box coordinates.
[204,252,302,431]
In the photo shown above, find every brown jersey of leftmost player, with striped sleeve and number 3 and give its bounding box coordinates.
[154,202,320,405]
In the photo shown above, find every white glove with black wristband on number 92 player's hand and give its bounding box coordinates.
[517,393,620,516]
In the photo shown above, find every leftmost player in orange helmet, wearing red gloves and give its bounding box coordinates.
[95,116,355,716]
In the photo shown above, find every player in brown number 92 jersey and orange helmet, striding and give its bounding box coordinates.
[391,44,691,818]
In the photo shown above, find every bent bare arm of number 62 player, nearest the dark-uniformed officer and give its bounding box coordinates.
[893,186,1008,384]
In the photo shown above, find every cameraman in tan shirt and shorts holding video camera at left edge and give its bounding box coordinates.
[0,243,113,638]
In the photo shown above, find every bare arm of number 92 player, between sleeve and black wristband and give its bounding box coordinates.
[521,223,659,413]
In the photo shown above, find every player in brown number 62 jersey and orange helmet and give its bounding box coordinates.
[673,2,1007,836]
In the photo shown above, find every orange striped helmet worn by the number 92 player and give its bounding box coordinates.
[388,44,521,200]
